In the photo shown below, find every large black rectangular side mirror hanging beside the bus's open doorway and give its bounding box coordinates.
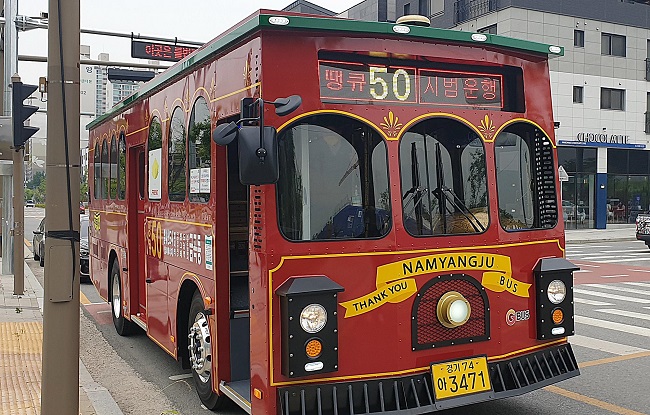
[238,126,280,185]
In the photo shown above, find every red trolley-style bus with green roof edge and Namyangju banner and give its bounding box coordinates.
[89,10,579,415]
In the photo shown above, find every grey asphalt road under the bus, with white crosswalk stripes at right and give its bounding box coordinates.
[22,231,650,415]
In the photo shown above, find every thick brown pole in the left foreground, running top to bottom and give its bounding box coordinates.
[41,0,81,415]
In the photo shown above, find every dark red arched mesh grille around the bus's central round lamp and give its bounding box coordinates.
[412,274,490,350]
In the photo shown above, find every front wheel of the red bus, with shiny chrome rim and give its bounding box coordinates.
[187,291,228,410]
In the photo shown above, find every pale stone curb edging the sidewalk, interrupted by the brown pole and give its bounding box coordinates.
[24,252,124,415]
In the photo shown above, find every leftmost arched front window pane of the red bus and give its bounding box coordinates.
[277,115,391,241]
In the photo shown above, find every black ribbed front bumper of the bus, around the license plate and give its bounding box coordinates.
[278,343,580,415]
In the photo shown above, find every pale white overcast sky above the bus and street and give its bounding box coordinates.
[17,0,361,84]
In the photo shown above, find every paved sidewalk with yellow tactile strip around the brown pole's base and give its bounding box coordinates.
[0,249,122,415]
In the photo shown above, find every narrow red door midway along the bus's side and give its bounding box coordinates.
[128,145,147,316]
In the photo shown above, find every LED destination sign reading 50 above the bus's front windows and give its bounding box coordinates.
[318,60,503,109]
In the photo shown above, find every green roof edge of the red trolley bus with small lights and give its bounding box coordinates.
[86,10,564,129]
